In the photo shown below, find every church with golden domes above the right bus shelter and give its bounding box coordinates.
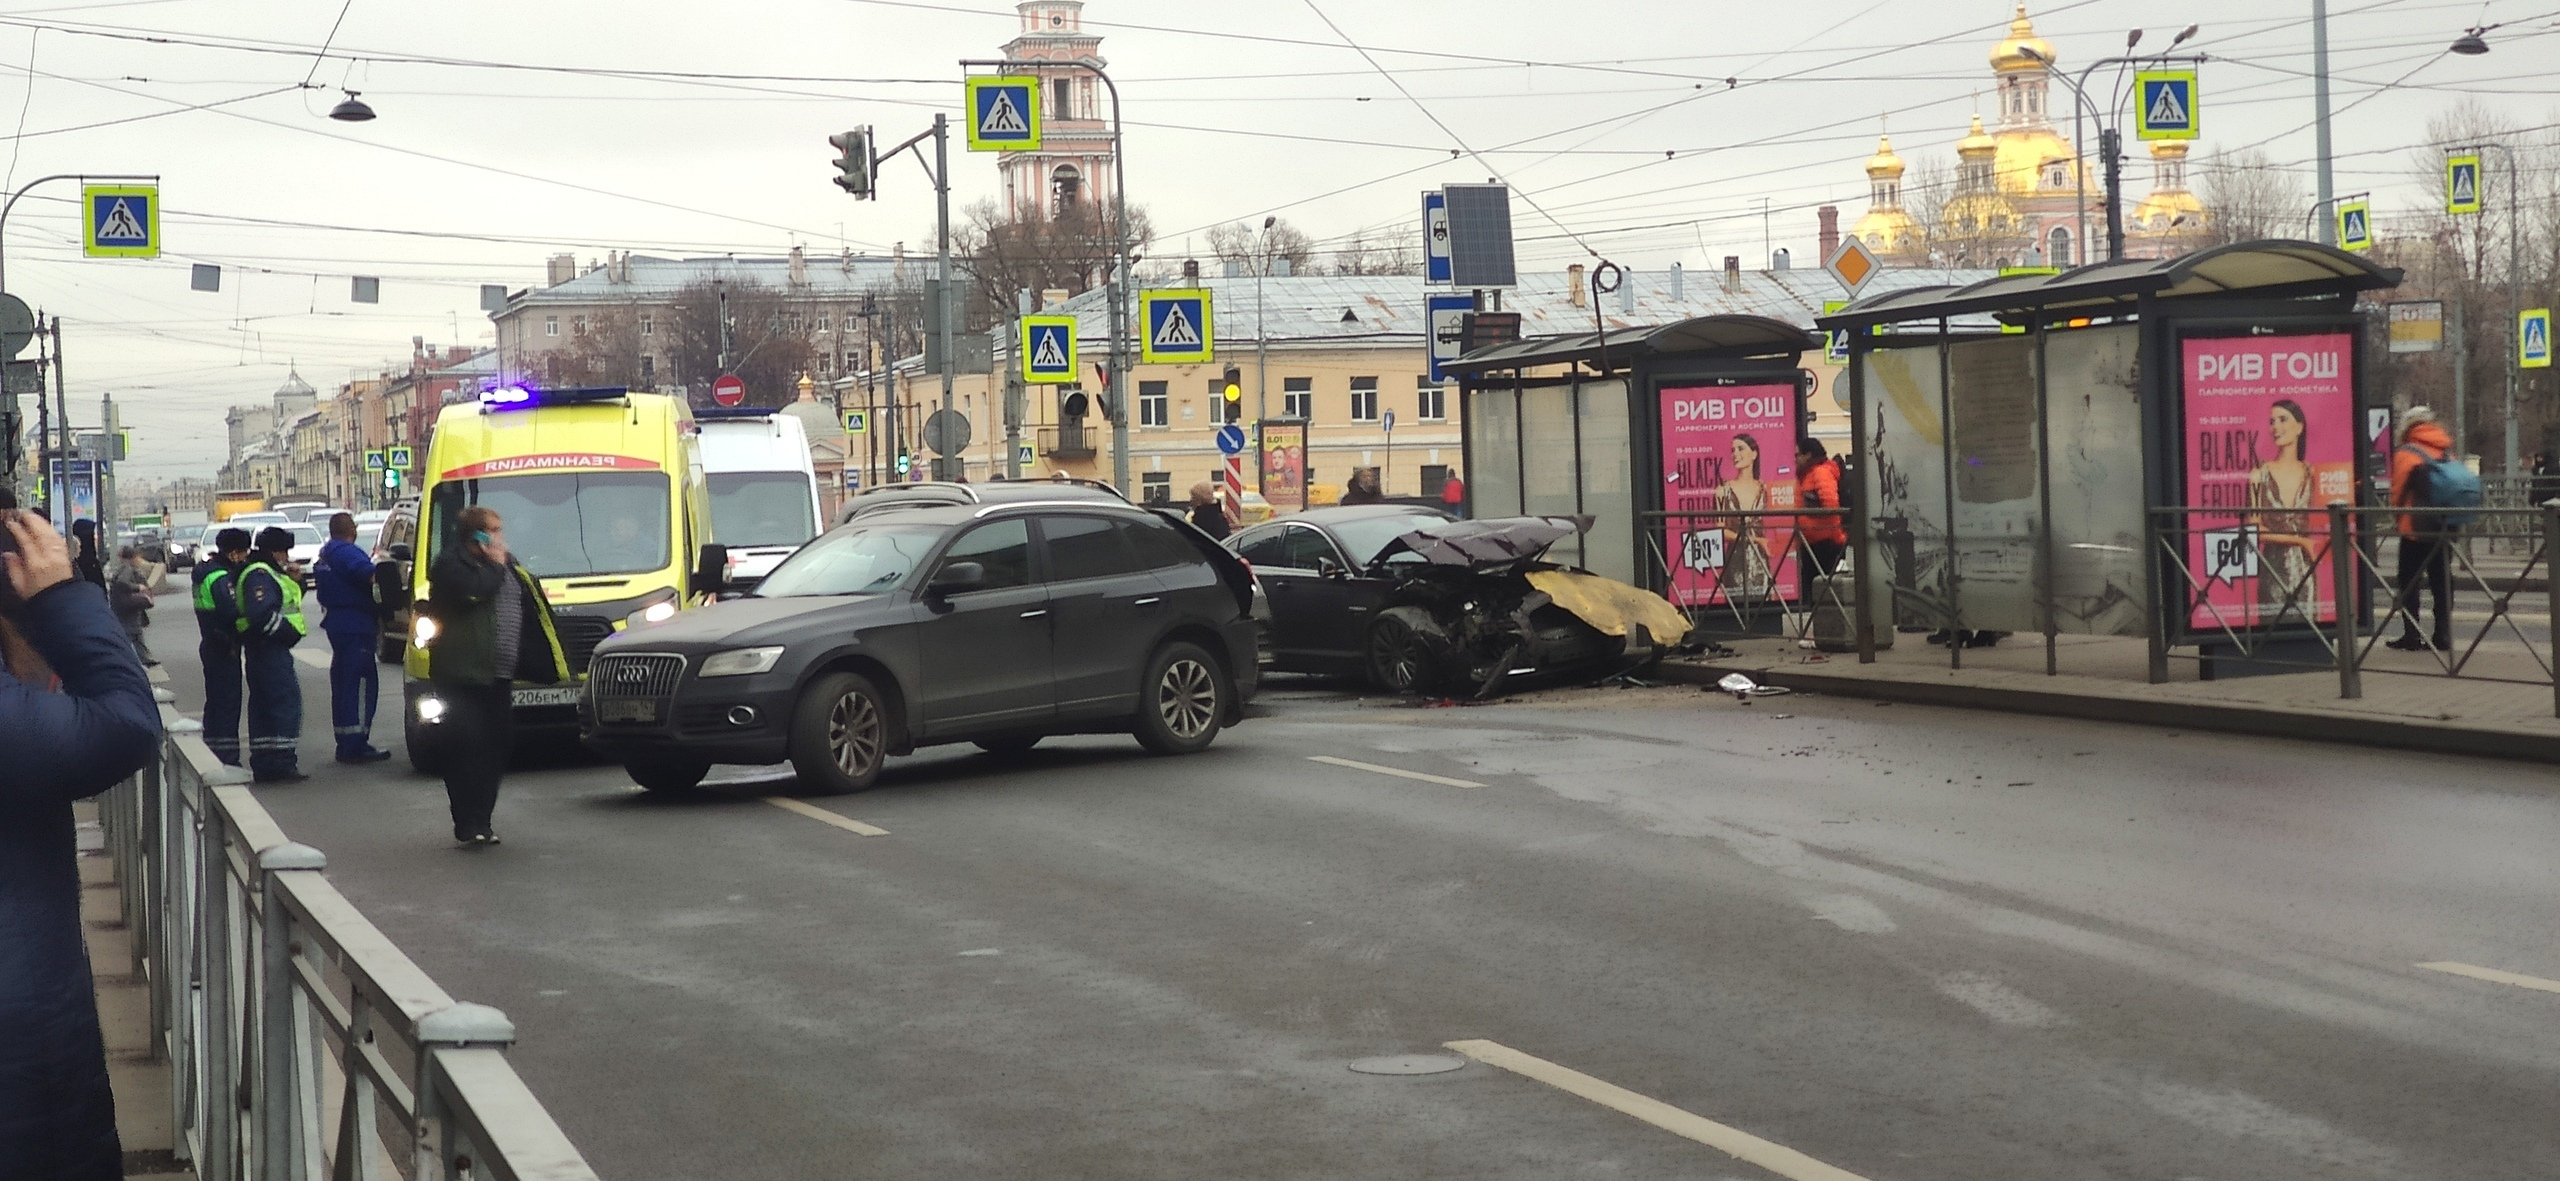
[1851,3,2207,266]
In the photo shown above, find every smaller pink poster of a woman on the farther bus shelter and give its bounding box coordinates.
[1661,384,1797,607]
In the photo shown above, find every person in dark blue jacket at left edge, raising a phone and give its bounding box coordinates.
[0,510,159,1181]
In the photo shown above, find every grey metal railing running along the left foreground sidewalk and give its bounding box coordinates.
[100,692,594,1181]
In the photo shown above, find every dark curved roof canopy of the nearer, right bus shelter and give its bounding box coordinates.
[1818,238,2401,330]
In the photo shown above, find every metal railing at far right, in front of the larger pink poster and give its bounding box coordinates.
[2150,505,2560,715]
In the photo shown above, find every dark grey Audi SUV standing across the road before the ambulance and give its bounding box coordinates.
[579,500,1260,792]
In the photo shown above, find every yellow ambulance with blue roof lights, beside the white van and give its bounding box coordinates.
[402,384,724,774]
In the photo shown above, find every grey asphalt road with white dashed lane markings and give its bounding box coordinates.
[156,599,2560,1181]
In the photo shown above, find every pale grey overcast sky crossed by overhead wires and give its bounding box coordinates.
[0,0,2519,479]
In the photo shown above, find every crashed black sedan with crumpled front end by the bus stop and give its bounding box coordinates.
[1229,505,1690,697]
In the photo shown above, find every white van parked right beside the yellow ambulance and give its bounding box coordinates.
[696,410,822,587]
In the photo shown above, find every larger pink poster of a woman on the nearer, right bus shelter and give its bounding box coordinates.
[2181,333,2358,633]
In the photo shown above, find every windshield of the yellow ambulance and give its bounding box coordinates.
[428,471,668,579]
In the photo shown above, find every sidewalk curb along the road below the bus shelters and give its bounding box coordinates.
[1661,661,2560,763]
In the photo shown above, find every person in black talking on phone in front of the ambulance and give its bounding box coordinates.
[420,505,568,848]
